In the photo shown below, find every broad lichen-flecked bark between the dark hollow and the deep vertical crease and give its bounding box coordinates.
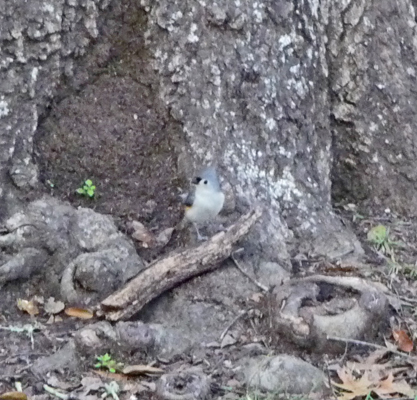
[142,1,356,258]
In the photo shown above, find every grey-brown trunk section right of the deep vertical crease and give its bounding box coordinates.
[327,0,417,215]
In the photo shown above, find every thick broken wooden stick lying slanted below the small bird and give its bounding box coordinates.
[99,209,261,321]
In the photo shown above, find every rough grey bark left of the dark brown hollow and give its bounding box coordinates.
[0,0,109,218]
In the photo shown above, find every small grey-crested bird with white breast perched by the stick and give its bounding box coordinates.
[183,167,224,240]
